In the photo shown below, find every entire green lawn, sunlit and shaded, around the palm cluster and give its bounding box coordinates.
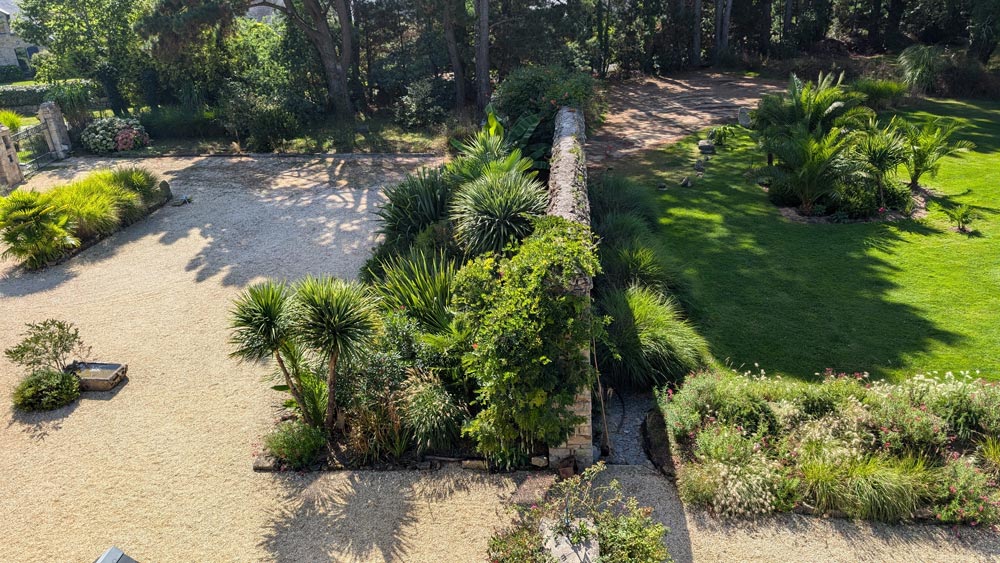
[617,100,1000,379]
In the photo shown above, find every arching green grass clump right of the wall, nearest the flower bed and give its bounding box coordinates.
[598,285,708,388]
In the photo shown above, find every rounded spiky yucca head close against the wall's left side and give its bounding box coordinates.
[451,171,548,255]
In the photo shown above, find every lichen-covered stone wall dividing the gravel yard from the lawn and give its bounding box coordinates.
[548,107,595,468]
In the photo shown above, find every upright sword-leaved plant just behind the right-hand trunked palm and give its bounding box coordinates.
[374,251,456,333]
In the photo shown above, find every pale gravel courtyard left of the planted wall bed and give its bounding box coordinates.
[0,157,517,562]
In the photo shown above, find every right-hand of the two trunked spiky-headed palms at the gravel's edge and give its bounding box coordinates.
[295,276,377,433]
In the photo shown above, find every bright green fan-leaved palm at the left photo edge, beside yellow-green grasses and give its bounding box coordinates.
[0,190,80,270]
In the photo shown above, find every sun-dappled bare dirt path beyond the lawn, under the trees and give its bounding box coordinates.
[586,73,784,166]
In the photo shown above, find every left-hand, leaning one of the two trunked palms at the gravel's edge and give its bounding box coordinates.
[229,280,319,426]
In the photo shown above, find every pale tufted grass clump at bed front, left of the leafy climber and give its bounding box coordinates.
[403,370,465,451]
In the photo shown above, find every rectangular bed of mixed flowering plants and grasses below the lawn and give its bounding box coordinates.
[659,371,1000,526]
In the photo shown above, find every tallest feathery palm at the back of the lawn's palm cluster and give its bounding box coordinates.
[752,73,872,166]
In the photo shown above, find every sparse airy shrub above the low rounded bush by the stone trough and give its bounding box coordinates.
[4,319,90,371]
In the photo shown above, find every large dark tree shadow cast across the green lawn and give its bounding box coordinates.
[625,146,963,378]
